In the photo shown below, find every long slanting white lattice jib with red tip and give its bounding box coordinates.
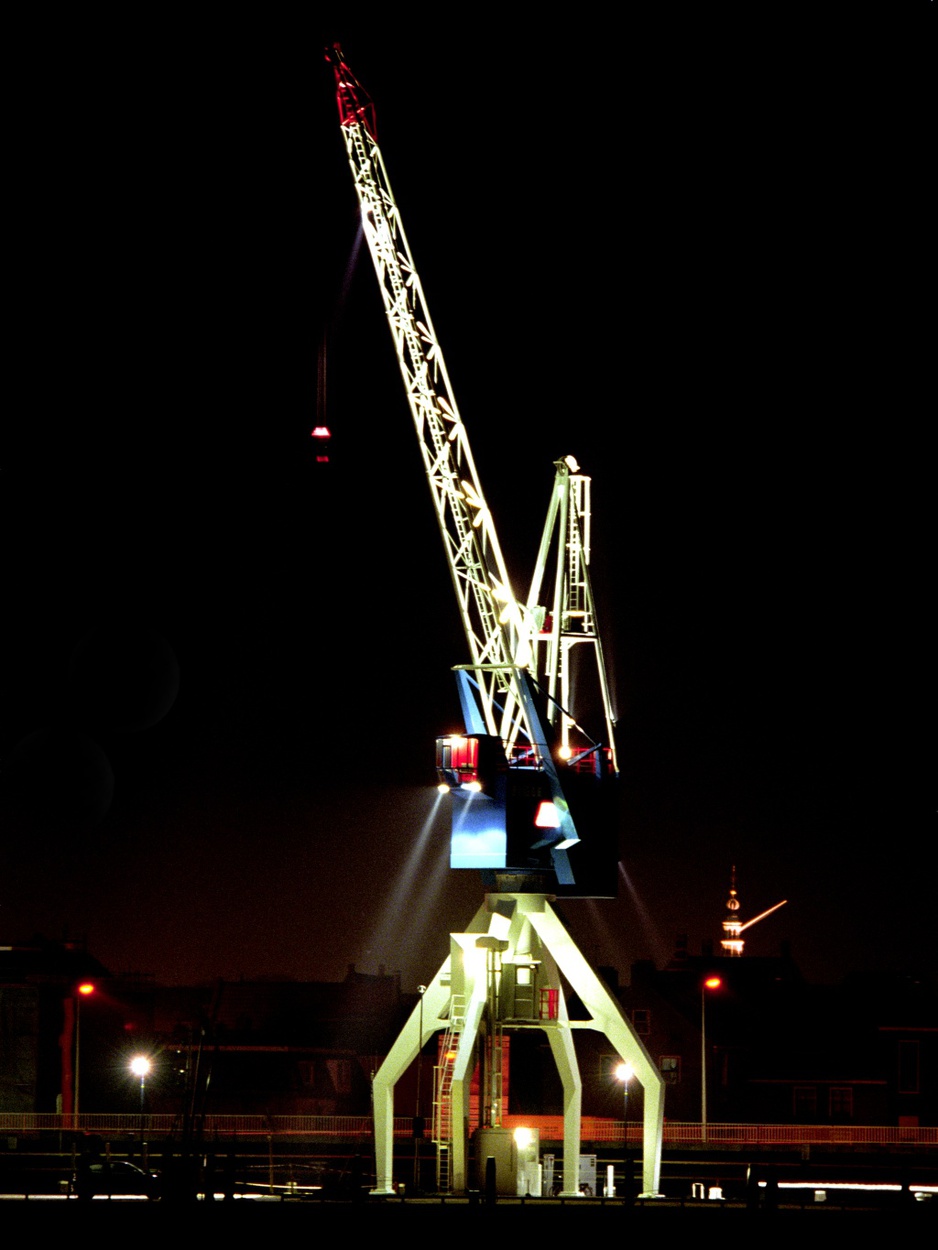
[326,46,539,751]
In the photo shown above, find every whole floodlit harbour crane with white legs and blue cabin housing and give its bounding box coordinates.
[326,45,664,1195]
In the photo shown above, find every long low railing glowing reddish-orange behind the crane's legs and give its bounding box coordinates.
[0,1111,938,1150]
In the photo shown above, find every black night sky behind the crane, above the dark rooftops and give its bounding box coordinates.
[0,15,938,986]
